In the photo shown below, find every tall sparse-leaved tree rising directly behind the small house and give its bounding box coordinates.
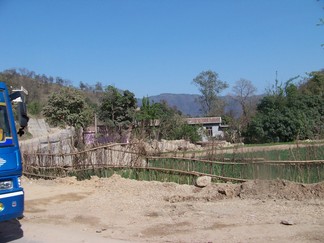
[193,70,228,116]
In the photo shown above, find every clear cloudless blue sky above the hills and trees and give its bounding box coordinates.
[0,0,324,98]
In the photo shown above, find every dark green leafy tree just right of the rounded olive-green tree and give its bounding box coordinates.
[98,85,137,133]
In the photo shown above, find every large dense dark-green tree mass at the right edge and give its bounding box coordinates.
[244,73,324,143]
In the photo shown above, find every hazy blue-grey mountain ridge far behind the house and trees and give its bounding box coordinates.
[138,93,262,117]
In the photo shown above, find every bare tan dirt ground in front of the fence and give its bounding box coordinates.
[0,175,324,243]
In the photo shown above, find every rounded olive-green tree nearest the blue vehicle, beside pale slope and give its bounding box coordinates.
[42,87,93,129]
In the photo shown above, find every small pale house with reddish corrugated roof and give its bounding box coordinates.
[186,117,228,142]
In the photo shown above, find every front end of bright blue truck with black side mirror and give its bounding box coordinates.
[0,82,28,221]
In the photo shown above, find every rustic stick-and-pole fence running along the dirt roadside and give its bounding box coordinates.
[22,144,324,184]
